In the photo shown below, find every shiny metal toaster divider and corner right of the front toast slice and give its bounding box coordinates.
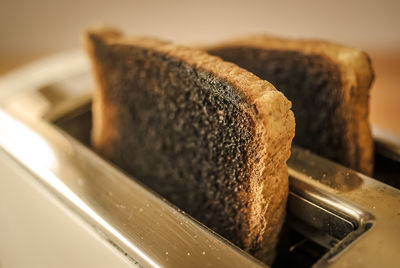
[288,148,400,267]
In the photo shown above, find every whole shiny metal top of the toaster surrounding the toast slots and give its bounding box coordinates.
[0,50,400,267]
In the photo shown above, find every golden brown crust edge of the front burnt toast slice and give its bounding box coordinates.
[87,29,295,258]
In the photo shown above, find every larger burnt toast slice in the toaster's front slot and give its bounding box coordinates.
[86,29,295,261]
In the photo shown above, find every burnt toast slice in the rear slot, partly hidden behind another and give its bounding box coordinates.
[207,35,374,175]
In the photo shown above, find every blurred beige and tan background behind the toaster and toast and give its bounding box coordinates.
[0,0,400,135]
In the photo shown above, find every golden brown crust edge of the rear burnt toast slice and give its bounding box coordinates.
[207,35,374,175]
